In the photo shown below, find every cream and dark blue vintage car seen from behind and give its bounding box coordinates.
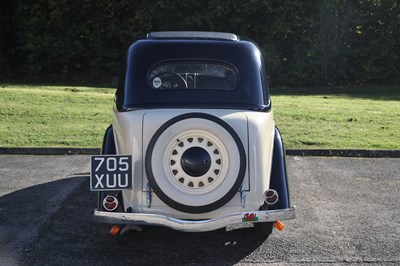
[90,32,295,236]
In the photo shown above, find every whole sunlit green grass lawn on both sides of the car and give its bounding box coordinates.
[0,84,400,149]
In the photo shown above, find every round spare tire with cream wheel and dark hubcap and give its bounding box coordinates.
[145,113,246,213]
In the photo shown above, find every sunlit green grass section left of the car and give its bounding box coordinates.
[0,85,115,147]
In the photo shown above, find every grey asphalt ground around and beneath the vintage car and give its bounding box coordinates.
[0,155,400,265]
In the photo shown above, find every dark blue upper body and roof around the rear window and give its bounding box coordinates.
[116,32,270,111]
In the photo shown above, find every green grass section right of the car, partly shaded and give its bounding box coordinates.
[271,86,400,149]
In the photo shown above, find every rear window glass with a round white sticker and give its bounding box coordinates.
[148,62,238,90]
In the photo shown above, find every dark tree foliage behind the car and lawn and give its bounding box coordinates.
[0,0,400,85]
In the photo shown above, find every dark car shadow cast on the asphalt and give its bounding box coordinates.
[0,176,266,265]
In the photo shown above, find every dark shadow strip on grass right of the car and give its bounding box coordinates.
[270,85,400,101]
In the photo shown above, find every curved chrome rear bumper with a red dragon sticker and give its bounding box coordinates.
[94,206,296,232]
